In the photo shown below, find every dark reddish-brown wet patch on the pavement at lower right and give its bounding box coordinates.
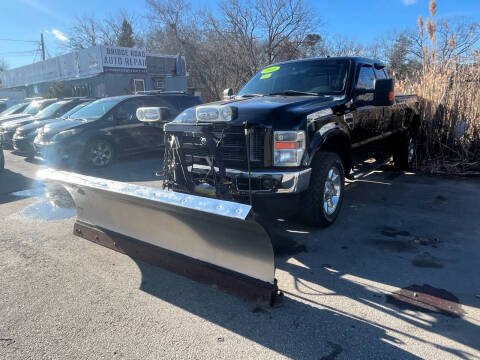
[387,284,465,318]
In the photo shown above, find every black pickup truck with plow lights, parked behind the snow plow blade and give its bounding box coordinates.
[156,57,419,226]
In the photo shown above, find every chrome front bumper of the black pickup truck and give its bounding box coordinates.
[188,164,312,195]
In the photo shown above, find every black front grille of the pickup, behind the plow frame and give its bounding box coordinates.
[181,124,266,168]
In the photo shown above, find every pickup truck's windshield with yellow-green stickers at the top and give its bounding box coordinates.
[238,59,349,96]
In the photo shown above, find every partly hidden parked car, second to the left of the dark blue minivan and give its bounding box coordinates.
[0,98,89,149]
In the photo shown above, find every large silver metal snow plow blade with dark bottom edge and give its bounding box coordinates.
[39,169,281,305]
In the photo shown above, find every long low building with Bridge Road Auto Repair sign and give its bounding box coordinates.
[0,45,188,98]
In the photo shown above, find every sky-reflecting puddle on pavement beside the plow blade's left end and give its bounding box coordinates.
[10,183,76,221]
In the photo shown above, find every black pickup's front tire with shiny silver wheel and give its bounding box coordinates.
[299,152,345,227]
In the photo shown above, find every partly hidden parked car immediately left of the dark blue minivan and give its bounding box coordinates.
[12,99,94,157]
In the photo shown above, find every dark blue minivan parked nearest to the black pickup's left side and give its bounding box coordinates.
[34,92,201,167]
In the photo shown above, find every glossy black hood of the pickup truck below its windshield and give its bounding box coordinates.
[188,95,343,127]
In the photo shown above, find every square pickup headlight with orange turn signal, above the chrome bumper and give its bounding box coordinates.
[273,131,305,166]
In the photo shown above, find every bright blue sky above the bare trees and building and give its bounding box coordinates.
[0,0,480,68]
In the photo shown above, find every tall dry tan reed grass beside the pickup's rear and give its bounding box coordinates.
[397,0,480,175]
